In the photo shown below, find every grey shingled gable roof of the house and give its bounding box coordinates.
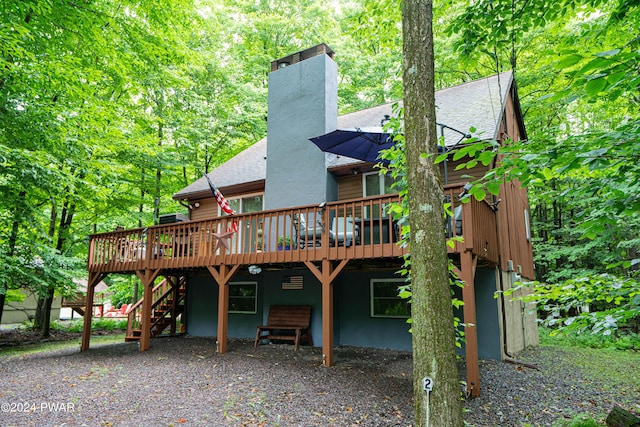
[173,71,513,199]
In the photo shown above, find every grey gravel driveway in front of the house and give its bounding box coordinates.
[0,337,640,426]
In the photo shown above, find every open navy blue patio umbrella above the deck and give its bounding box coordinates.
[309,127,394,163]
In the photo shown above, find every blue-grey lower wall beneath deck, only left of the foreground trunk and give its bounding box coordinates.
[182,269,411,350]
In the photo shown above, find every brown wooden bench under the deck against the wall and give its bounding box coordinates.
[254,305,313,351]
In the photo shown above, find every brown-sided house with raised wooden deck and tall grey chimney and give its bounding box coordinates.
[82,44,537,395]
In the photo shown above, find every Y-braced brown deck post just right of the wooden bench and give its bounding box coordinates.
[305,259,349,366]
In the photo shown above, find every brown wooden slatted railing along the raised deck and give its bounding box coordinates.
[88,190,497,272]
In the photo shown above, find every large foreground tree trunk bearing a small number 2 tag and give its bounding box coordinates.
[402,0,463,427]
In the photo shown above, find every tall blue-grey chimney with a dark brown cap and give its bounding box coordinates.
[265,44,338,209]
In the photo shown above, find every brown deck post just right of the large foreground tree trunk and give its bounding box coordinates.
[460,251,480,397]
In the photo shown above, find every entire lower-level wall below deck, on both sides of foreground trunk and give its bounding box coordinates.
[182,268,516,360]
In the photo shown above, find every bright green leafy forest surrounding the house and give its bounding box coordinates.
[0,0,640,342]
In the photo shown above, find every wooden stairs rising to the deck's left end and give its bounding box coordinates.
[124,276,187,341]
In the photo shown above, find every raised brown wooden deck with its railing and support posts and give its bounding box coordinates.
[81,185,498,396]
